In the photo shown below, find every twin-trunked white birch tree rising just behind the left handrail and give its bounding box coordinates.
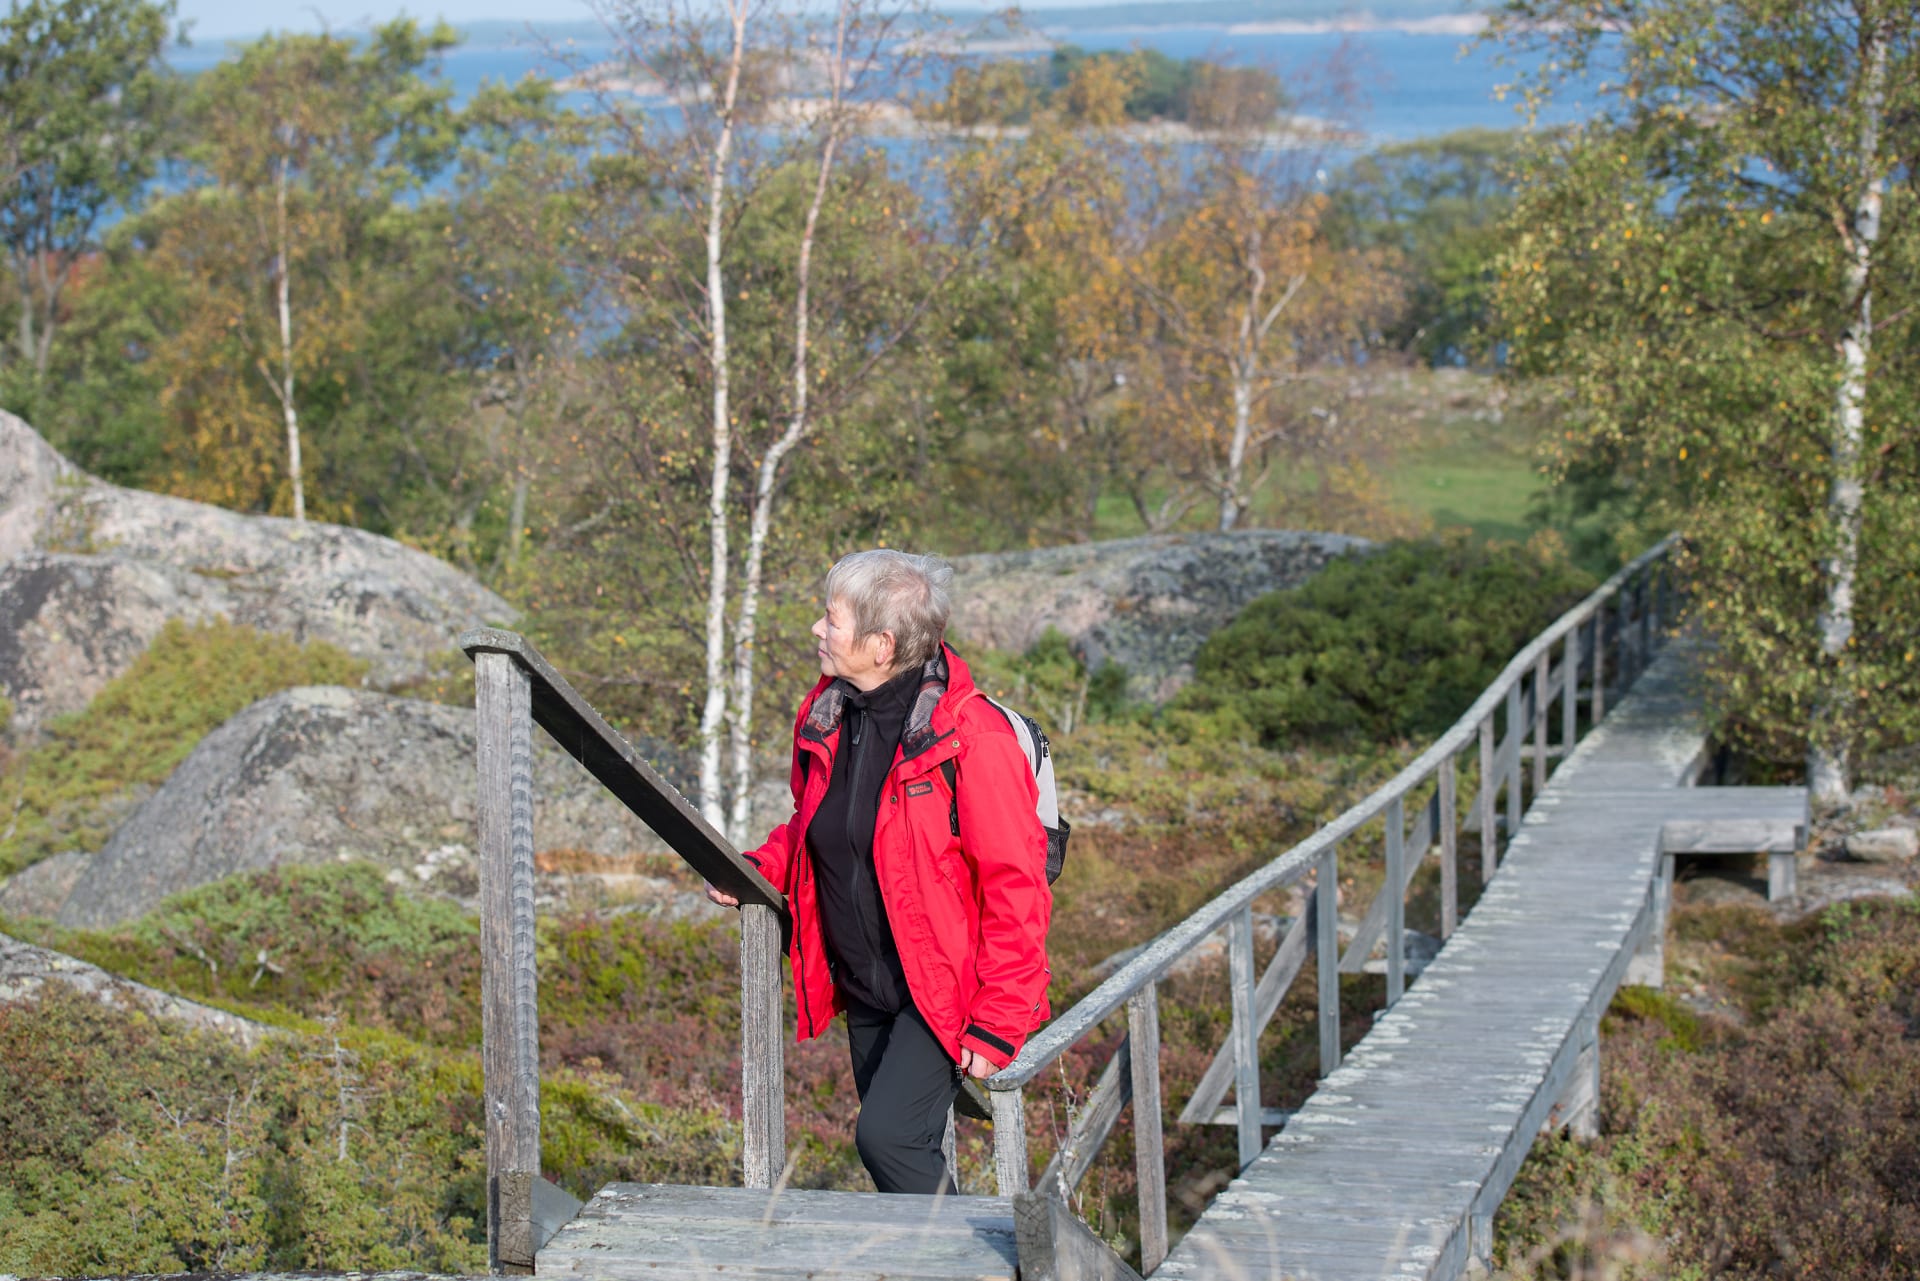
[580,0,948,839]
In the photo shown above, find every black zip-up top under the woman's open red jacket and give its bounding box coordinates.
[806,666,922,1014]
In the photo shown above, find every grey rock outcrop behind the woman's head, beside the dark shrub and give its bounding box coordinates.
[952,530,1369,699]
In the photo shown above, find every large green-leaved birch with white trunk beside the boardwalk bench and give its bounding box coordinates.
[1500,0,1920,803]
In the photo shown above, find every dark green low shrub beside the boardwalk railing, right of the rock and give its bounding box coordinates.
[1175,538,1594,747]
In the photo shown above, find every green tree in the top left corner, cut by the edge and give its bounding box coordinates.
[0,0,173,397]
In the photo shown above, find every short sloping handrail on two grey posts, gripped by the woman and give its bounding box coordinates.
[459,628,787,1273]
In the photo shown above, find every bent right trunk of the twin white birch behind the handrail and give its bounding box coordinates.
[728,0,847,845]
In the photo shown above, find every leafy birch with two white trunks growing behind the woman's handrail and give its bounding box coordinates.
[560,0,967,839]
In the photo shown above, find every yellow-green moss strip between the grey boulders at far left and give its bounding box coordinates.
[0,620,367,876]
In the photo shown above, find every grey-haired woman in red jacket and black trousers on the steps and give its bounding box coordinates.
[707,549,1052,1193]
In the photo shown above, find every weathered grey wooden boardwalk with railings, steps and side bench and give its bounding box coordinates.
[461,544,1807,1281]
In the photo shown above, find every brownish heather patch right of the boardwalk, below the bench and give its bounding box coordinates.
[1498,897,1920,1281]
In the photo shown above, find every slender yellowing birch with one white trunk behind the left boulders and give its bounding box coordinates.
[154,19,455,519]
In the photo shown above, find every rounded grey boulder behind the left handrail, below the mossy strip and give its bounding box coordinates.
[56,686,725,928]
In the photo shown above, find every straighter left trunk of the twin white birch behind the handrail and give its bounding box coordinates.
[701,0,747,828]
